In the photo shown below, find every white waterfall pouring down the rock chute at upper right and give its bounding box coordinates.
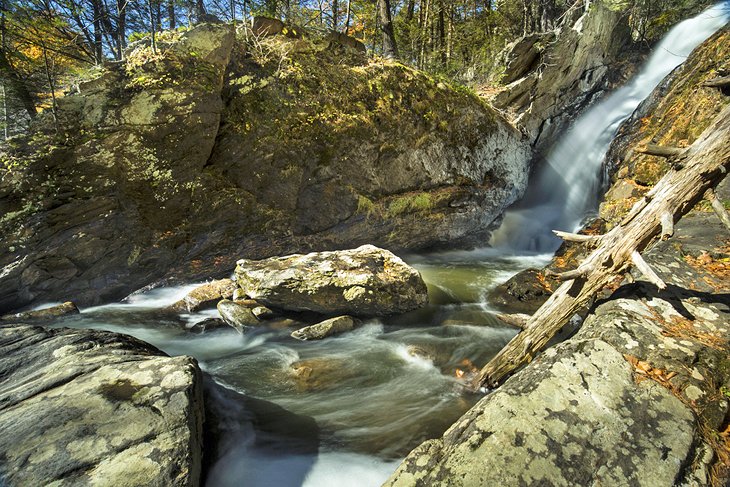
[490,1,730,252]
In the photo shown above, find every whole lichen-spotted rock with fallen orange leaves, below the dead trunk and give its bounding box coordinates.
[386,290,729,486]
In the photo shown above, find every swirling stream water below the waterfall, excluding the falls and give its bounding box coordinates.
[47,249,548,487]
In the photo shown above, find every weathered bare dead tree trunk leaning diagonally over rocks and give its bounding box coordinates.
[474,106,730,388]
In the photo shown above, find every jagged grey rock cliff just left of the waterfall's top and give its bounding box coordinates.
[492,0,642,153]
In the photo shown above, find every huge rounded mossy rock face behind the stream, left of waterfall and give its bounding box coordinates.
[0,24,529,311]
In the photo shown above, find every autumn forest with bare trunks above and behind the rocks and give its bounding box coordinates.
[0,0,709,139]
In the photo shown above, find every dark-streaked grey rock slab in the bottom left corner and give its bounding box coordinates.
[0,325,203,486]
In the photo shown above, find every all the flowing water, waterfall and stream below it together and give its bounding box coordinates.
[47,2,728,487]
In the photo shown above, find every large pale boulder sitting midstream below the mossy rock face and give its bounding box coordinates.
[235,245,428,316]
